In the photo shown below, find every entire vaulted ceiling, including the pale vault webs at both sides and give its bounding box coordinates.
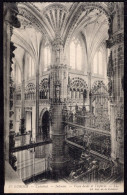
[12,2,112,67]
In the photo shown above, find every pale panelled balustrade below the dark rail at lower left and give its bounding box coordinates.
[15,145,51,182]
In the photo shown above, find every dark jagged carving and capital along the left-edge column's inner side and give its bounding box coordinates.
[3,2,20,171]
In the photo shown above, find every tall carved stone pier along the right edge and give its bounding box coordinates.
[107,2,124,170]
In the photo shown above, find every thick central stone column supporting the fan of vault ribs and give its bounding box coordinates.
[50,38,68,177]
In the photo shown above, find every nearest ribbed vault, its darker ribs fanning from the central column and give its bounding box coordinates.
[15,2,110,43]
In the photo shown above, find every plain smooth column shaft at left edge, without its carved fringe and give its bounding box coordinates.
[3,17,10,161]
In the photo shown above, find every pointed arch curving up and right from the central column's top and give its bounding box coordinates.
[63,2,113,47]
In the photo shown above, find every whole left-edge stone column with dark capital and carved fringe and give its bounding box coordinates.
[3,2,20,164]
